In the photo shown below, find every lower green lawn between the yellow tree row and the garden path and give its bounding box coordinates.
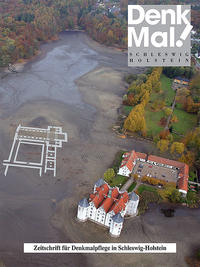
[145,109,164,137]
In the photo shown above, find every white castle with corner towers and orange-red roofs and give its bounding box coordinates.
[77,179,139,237]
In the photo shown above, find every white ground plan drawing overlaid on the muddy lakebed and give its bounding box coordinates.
[3,125,67,177]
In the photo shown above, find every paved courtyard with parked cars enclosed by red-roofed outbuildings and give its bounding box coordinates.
[133,161,178,183]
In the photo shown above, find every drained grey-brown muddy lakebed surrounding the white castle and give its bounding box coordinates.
[0,32,200,267]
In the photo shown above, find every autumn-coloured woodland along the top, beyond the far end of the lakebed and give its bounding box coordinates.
[0,0,200,66]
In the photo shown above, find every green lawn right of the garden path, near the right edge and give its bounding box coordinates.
[173,108,197,135]
